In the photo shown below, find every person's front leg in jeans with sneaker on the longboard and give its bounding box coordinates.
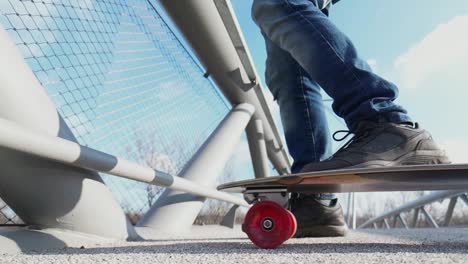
[252,0,449,172]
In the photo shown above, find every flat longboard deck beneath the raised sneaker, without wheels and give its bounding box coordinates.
[218,164,468,193]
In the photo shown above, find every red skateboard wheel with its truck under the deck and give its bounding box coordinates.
[242,189,297,249]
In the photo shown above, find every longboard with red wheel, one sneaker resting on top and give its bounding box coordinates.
[218,164,468,249]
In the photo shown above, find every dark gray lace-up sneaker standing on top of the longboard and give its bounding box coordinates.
[301,122,450,172]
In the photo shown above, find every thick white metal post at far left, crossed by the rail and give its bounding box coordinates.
[0,26,135,239]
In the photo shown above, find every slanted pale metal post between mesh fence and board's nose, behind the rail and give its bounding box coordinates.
[138,104,255,233]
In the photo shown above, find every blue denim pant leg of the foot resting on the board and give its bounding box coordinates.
[252,0,410,130]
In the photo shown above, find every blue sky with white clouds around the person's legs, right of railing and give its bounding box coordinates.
[232,0,468,168]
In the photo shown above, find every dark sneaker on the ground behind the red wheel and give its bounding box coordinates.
[289,193,348,238]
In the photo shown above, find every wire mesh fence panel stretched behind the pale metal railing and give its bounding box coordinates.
[0,0,229,224]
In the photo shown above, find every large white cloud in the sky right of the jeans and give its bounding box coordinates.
[394,14,468,167]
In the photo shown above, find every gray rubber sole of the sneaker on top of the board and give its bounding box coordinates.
[346,150,451,169]
